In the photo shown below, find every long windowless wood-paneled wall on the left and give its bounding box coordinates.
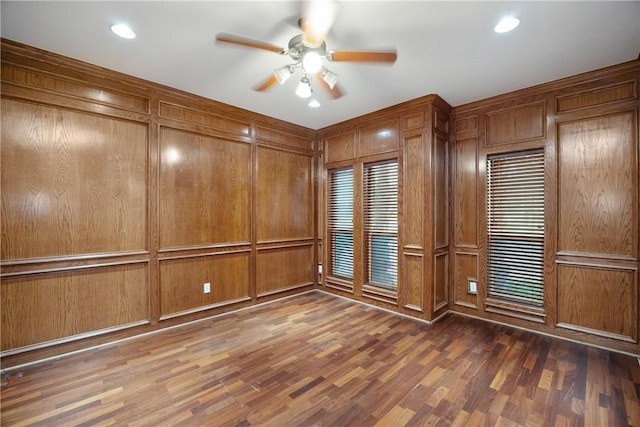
[0,40,316,364]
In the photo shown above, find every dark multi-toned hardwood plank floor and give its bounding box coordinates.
[1,292,640,426]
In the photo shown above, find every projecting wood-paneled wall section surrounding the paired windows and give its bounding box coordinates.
[318,95,451,320]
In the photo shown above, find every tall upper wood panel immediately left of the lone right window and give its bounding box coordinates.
[453,137,478,247]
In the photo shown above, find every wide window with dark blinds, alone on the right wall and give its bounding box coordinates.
[487,150,544,308]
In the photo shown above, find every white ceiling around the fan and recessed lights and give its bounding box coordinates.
[1,0,640,129]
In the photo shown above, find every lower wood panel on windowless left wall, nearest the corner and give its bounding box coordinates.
[256,245,315,297]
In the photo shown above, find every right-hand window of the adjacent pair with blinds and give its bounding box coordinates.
[363,160,398,290]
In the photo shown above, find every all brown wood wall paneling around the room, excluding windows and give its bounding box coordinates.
[0,40,640,365]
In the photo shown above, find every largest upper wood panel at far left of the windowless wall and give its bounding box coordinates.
[1,99,148,260]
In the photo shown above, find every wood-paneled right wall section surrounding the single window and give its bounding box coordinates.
[450,61,640,354]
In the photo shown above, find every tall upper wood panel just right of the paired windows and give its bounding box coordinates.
[402,134,426,248]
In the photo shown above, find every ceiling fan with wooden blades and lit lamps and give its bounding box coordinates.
[216,0,397,99]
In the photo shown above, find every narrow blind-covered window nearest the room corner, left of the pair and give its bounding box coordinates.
[327,167,353,280]
